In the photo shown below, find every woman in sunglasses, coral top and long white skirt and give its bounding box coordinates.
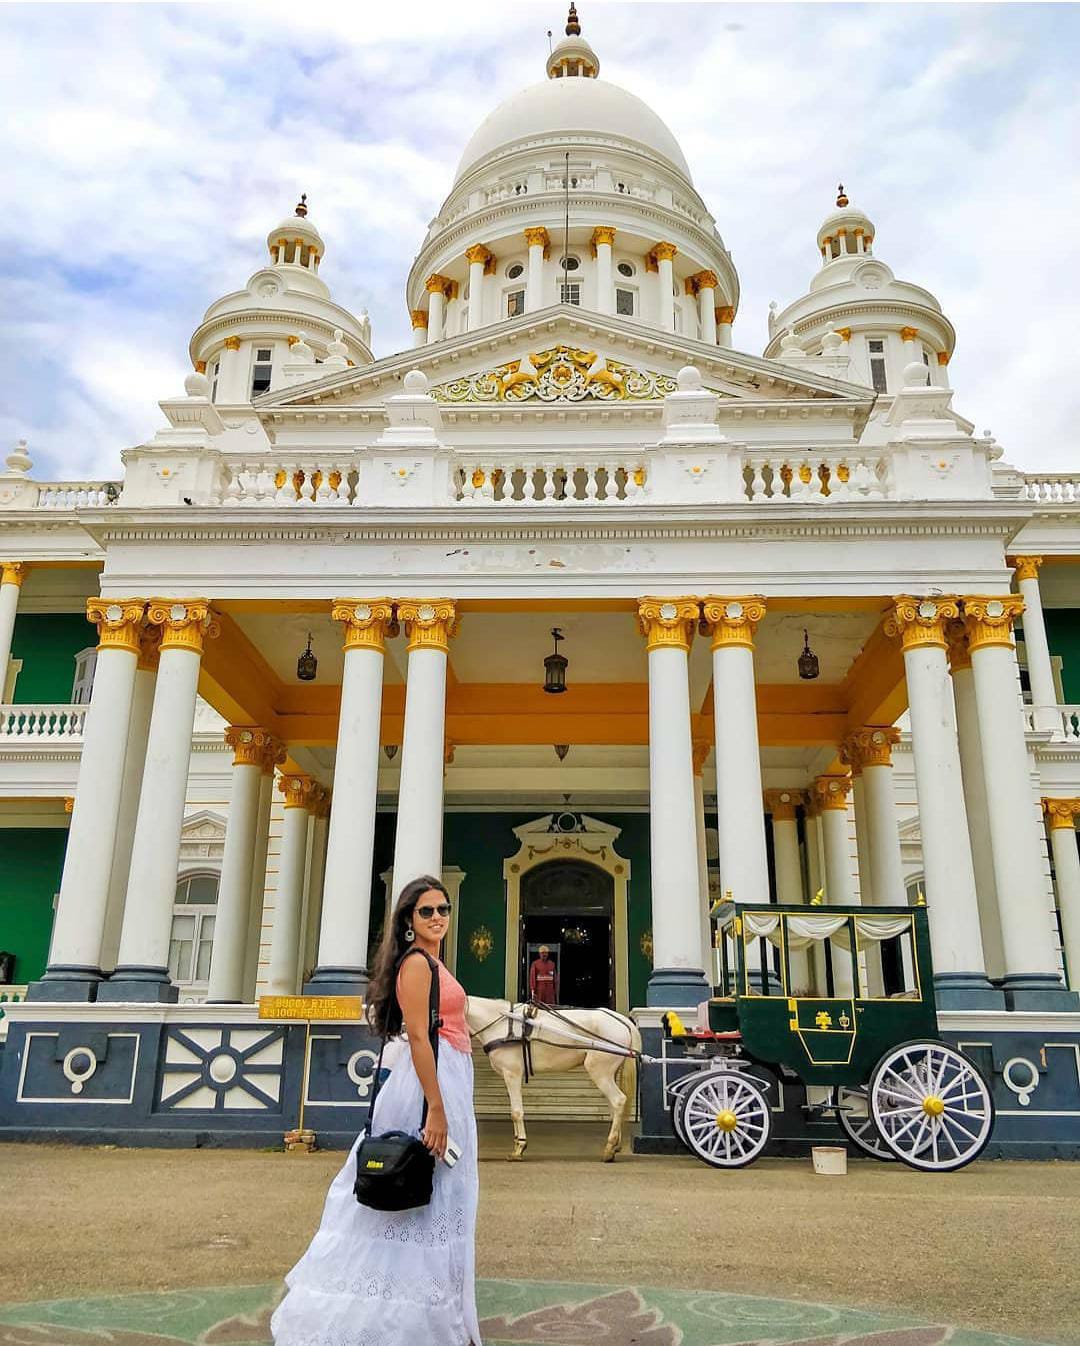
[271,876,481,1346]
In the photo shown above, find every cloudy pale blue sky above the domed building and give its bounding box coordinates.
[0,0,1080,479]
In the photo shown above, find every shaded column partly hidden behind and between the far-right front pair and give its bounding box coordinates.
[945,638,1005,980]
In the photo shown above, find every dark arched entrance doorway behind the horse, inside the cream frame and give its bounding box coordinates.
[517,860,615,1010]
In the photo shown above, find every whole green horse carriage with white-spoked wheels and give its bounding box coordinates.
[665,900,994,1172]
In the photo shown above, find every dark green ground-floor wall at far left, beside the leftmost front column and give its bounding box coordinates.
[0,828,67,983]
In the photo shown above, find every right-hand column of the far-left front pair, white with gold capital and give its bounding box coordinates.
[98,599,217,1000]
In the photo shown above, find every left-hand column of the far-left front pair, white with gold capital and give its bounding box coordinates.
[30,598,145,1000]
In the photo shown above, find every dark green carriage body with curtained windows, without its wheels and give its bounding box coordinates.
[708,902,939,1085]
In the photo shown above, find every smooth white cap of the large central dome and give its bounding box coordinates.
[454,65,692,186]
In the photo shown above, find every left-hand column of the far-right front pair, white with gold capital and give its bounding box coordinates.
[886,605,1002,1010]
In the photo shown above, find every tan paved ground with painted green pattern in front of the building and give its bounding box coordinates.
[0,1124,1080,1346]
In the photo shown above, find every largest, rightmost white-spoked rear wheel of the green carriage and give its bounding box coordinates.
[870,1042,994,1172]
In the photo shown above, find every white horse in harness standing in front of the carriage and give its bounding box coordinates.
[466,996,641,1164]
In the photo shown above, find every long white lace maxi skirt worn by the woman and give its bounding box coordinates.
[271,1042,481,1346]
